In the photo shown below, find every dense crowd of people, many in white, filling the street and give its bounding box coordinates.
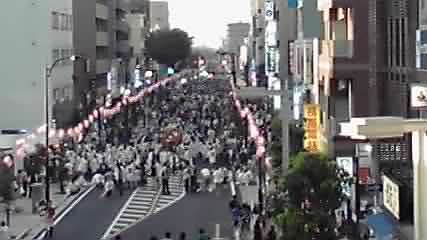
[7,68,278,240]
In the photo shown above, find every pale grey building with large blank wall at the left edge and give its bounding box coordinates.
[0,0,51,131]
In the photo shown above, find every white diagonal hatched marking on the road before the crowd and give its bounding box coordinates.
[102,176,185,239]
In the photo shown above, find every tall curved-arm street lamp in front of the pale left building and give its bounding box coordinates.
[44,55,82,203]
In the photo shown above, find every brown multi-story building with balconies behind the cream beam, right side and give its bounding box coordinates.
[313,0,417,181]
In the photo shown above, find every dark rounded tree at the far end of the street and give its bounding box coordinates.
[145,29,192,67]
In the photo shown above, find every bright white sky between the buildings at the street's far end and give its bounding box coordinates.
[167,0,250,48]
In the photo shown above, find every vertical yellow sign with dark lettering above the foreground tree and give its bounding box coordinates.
[304,104,320,153]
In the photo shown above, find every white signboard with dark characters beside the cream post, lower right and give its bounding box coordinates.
[383,175,400,219]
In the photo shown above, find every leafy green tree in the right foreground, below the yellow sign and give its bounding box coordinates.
[273,152,344,240]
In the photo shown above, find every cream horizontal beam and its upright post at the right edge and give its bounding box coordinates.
[340,117,427,240]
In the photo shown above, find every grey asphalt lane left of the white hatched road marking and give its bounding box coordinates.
[50,189,131,240]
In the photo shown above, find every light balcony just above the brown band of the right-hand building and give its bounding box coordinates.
[321,40,354,58]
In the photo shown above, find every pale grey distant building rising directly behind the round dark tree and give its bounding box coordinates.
[150,1,170,30]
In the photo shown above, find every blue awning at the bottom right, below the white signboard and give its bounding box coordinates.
[368,213,398,240]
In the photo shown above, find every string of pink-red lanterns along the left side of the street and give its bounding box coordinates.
[16,70,188,157]
